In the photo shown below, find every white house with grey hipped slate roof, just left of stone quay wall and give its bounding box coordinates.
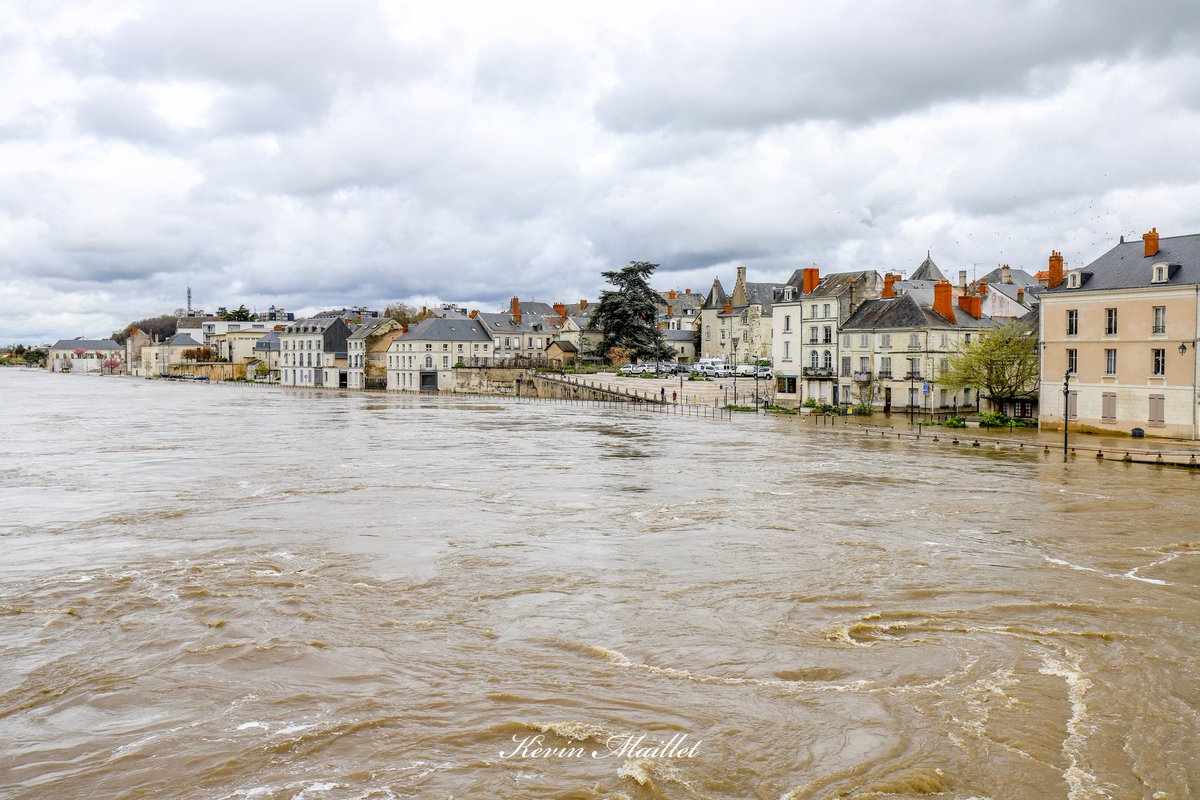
[386,317,493,392]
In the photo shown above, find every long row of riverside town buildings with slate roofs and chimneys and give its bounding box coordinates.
[35,229,1200,439]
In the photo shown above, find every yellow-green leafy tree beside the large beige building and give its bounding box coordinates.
[938,320,1038,399]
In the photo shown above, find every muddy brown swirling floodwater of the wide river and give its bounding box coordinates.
[0,369,1200,800]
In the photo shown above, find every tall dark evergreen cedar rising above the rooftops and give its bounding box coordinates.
[588,261,671,359]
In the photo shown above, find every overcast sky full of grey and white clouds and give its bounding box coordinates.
[0,0,1200,343]
